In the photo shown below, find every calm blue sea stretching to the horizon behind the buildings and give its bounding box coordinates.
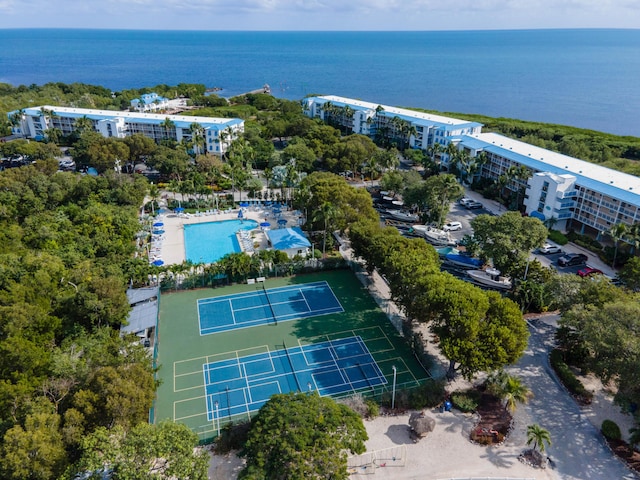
[0,29,640,136]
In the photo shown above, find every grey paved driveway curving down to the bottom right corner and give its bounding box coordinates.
[509,320,638,480]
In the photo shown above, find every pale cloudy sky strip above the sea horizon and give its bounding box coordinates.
[0,0,640,31]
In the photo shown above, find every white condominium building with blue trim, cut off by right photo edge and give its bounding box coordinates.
[455,133,640,233]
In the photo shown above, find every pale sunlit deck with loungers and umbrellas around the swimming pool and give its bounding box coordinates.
[150,207,300,265]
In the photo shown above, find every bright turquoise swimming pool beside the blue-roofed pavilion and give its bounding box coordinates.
[184,220,258,263]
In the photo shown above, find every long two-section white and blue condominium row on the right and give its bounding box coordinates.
[303,96,640,235]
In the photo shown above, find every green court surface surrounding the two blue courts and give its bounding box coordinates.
[154,270,428,441]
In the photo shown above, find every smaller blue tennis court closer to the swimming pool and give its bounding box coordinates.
[198,282,344,335]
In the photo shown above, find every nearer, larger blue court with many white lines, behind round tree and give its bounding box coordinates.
[204,336,387,421]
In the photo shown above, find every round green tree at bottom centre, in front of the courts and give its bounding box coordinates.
[240,393,367,480]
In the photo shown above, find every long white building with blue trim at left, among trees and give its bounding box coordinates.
[8,105,244,155]
